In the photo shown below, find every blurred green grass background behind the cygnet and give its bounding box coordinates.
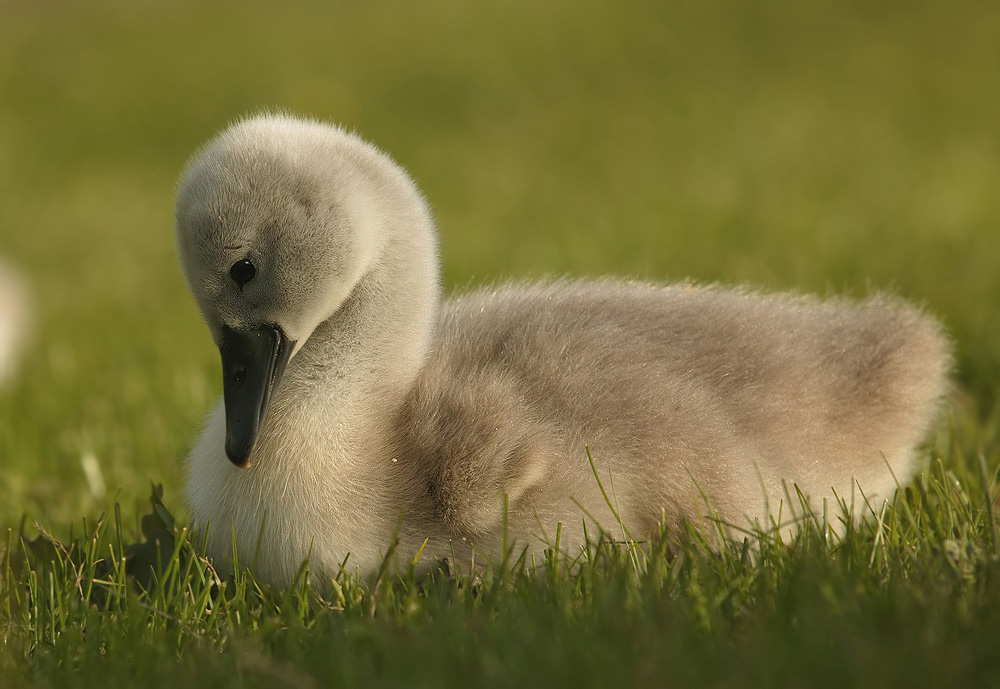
[0,0,1000,524]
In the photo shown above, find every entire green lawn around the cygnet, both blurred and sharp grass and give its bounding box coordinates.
[0,0,1000,687]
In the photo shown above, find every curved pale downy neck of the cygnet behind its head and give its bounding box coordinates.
[274,177,439,428]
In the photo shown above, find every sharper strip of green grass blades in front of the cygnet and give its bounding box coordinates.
[0,416,1000,687]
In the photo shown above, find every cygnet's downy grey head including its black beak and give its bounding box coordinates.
[176,115,395,467]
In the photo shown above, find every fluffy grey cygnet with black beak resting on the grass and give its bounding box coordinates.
[177,115,949,585]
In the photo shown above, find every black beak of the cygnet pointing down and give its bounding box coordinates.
[219,325,295,468]
